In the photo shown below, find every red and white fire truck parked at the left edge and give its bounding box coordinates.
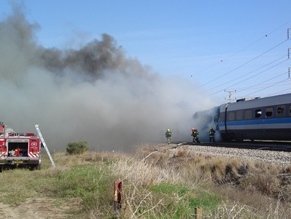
[0,122,42,172]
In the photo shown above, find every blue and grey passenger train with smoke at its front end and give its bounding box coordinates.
[193,93,291,141]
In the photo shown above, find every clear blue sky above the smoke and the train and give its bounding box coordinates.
[0,0,291,102]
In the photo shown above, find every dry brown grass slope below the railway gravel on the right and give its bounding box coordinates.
[134,146,291,218]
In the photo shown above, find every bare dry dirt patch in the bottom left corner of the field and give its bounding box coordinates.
[0,198,79,219]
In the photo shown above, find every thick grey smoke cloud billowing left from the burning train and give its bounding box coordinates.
[0,7,211,151]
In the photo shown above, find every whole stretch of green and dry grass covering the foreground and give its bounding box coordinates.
[0,142,291,219]
